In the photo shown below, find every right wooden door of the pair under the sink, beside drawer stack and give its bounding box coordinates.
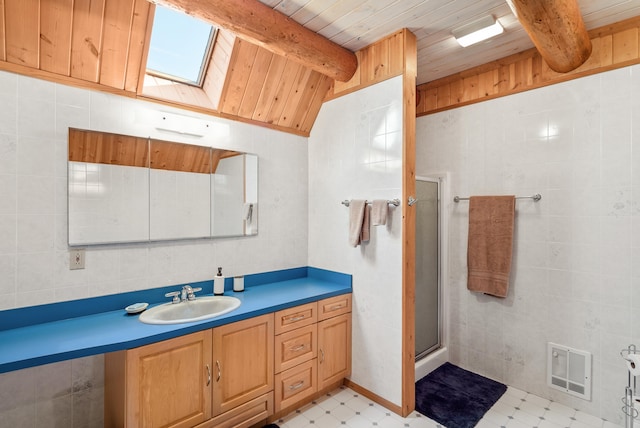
[213,313,274,416]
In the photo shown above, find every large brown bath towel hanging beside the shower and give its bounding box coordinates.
[467,196,516,297]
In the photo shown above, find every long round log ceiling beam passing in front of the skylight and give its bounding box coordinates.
[151,0,358,82]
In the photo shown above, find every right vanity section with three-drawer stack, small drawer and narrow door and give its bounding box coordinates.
[275,294,351,412]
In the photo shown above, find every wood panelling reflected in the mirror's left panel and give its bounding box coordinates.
[69,128,149,168]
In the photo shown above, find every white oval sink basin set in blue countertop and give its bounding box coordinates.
[140,296,240,324]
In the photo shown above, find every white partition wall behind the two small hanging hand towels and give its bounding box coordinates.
[308,77,402,405]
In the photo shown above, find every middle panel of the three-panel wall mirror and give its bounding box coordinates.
[149,140,211,241]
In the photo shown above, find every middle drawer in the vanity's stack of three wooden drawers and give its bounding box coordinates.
[275,324,318,373]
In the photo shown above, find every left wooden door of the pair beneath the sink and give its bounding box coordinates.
[126,330,211,428]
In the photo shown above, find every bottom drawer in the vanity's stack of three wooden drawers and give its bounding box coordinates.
[275,359,318,412]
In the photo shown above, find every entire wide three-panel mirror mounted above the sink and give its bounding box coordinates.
[68,129,258,246]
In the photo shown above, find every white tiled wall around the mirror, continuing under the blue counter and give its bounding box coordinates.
[0,72,309,427]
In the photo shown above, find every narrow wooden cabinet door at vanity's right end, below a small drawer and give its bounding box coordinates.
[318,313,351,390]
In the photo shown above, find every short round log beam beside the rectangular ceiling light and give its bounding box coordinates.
[511,0,591,73]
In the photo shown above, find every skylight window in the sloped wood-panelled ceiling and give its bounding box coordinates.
[147,5,216,86]
